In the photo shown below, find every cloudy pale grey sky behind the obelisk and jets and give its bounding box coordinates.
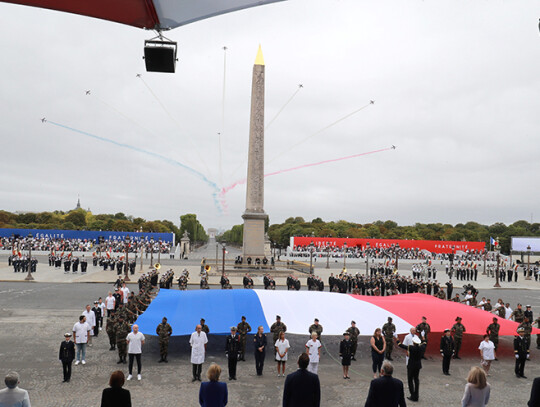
[0,0,540,228]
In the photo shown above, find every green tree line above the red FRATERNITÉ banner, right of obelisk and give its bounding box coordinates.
[219,217,540,254]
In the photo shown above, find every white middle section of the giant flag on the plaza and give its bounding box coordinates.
[254,290,412,335]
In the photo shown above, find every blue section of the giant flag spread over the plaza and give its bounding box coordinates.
[135,289,270,336]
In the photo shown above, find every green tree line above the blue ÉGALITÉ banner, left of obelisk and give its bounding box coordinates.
[0,209,208,242]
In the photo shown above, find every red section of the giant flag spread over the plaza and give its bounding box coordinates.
[352,294,540,336]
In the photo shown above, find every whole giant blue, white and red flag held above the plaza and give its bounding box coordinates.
[137,289,540,336]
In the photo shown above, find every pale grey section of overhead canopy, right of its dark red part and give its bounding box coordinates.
[154,0,284,29]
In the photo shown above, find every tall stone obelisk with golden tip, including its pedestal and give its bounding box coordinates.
[242,46,267,263]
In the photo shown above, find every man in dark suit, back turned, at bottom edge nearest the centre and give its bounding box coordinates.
[283,353,321,407]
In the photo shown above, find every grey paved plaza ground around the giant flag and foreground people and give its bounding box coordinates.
[0,282,540,407]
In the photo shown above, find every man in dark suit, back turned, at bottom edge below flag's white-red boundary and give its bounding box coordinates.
[364,360,407,407]
